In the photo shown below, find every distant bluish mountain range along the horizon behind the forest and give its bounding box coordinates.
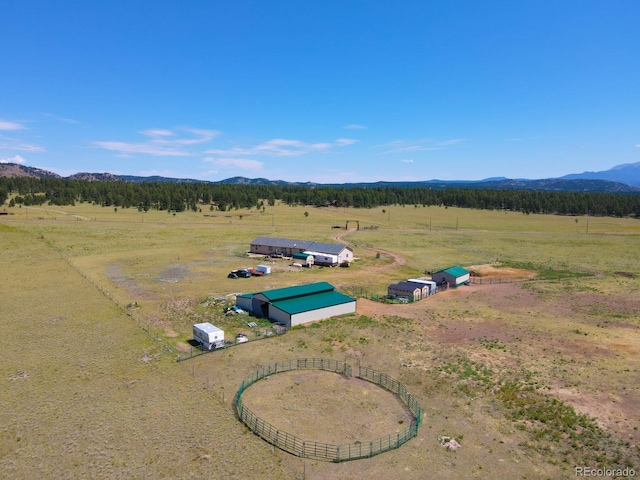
[0,162,640,193]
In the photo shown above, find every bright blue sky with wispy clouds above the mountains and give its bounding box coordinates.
[0,0,640,183]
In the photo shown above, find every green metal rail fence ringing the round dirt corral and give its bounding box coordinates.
[233,358,421,462]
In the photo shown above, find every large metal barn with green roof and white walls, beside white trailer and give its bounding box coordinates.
[236,282,356,328]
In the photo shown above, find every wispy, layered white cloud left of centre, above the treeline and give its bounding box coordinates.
[91,128,220,157]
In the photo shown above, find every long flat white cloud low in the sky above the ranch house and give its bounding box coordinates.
[205,138,357,157]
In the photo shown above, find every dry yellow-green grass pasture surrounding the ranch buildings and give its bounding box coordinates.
[0,204,640,480]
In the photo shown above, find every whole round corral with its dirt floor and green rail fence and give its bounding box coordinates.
[235,358,420,462]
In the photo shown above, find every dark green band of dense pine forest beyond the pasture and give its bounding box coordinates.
[0,177,640,218]
